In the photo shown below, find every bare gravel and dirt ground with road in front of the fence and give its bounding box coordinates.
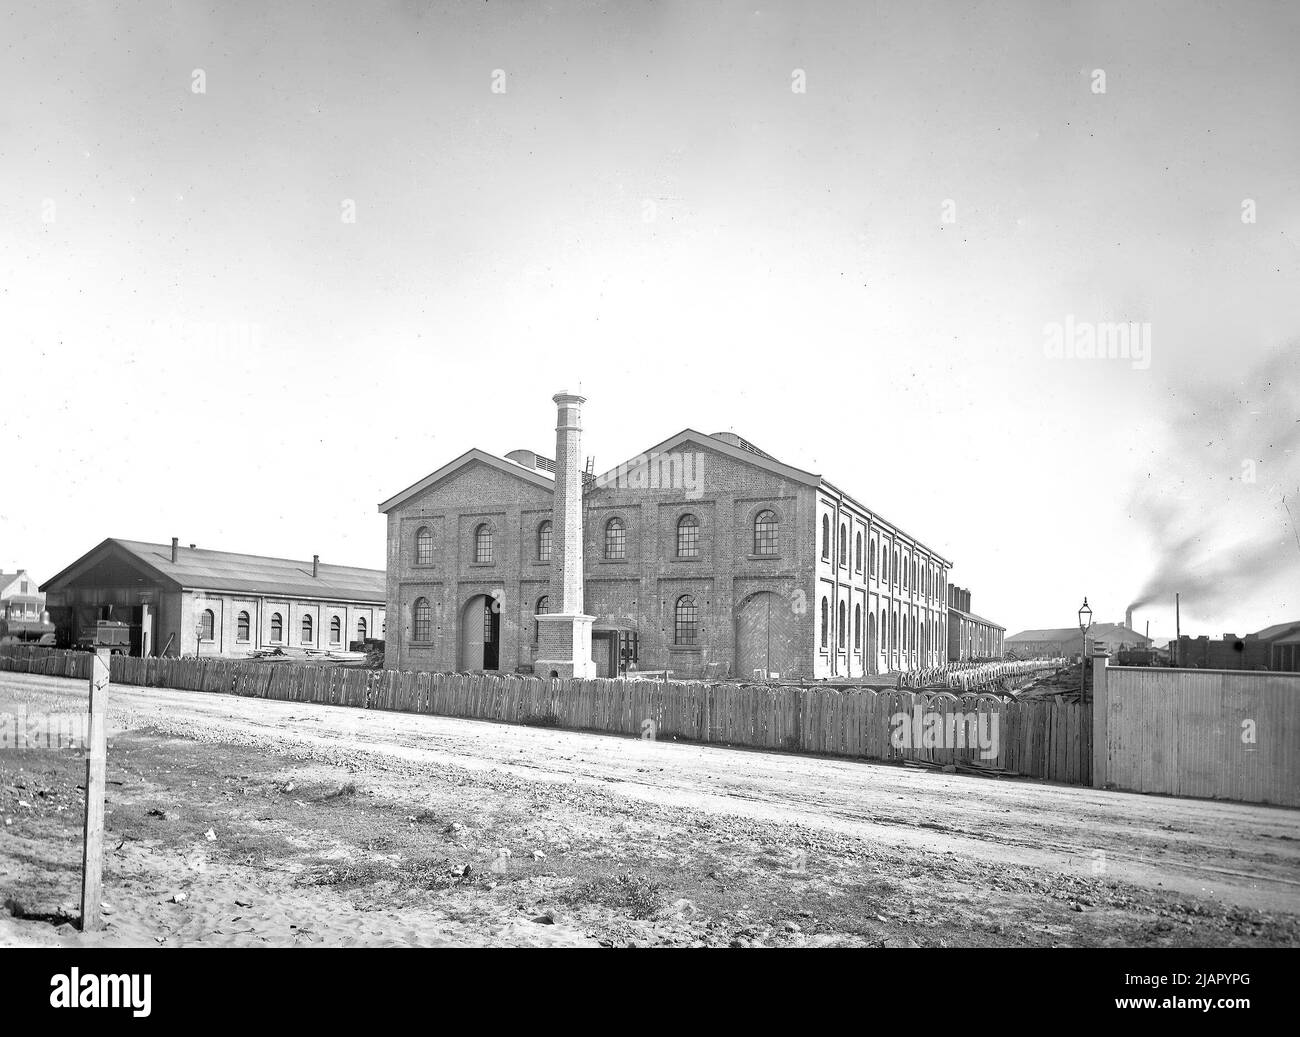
[0,673,1300,946]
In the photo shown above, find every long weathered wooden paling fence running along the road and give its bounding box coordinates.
[0,645,1092,784]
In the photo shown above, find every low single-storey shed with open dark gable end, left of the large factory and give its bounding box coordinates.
[42,538,385,656]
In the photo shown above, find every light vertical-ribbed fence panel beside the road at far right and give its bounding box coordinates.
[1093,660,1300,807]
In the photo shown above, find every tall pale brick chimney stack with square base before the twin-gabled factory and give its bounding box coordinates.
[534,392,595,678]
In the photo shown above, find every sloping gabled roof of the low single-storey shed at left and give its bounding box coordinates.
[40,537,386,604]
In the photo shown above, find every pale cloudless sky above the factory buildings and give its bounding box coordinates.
[0,0,1300,637]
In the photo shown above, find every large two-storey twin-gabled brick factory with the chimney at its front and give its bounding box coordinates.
[380,394,950,678]
